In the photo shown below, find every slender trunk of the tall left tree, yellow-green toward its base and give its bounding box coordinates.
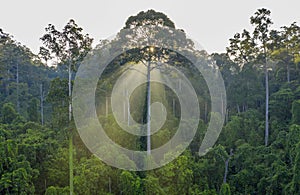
[68,62,74,195]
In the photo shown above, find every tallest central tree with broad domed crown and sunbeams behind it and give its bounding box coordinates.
[121,10,193,154]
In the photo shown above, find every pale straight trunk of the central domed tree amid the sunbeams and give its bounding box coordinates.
[147,60,151,155]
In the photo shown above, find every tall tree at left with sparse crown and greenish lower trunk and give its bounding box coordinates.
[40,19,93,195]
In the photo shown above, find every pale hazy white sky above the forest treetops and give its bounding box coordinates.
[0,0,300,53]
